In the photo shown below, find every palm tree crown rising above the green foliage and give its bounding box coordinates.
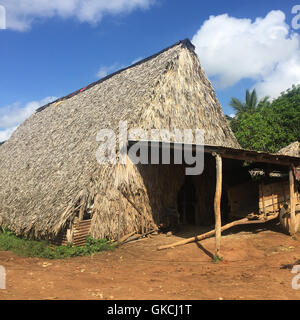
[230,89,270,115]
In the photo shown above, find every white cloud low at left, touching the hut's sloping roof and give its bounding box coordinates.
[0,97,57,141]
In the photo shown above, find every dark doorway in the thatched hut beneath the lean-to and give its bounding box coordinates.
[177,176,196,224]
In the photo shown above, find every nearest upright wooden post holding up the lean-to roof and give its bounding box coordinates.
[214,154,222,258]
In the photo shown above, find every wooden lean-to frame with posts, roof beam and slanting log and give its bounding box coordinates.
[128,140,300,257]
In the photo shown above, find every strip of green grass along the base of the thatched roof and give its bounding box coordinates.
[0,228,116,259]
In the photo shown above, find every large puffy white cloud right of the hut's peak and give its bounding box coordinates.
[192,11,300,97]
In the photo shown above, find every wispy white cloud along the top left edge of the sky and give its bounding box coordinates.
[1,0,156,31]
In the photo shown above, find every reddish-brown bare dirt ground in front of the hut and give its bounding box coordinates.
[0,224,300,300]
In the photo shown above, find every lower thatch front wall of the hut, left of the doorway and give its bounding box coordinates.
[91,163,184,238]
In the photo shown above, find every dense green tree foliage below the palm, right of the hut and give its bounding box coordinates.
[230,85,300,152]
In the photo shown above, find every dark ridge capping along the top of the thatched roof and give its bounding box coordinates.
[36,38,195,113]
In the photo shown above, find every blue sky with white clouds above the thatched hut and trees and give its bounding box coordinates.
[0,0,300,140]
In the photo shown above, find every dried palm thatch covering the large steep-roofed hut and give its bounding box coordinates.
[0,40,239,238]
